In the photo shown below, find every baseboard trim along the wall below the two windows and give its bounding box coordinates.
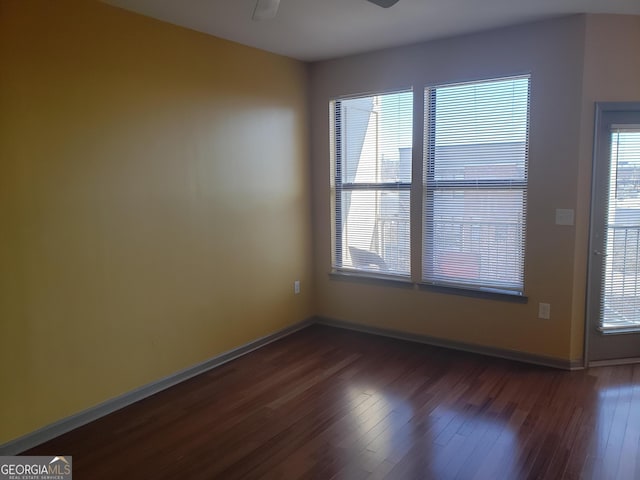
[315,317,584,370]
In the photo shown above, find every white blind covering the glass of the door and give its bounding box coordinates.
[600,126,640,331]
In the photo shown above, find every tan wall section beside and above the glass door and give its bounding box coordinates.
[571,15,640,357]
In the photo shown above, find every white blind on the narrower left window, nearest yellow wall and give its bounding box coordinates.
[331,91,413,277]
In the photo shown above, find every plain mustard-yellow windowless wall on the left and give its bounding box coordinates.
[0,0,313,444]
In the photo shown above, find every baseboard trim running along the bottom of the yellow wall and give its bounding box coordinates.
[0,318,315,456]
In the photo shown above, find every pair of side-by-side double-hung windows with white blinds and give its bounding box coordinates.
[330,76,530,295]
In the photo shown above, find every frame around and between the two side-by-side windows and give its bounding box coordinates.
[329,72,532,303]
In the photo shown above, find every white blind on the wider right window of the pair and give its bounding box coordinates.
[422,76,529,294]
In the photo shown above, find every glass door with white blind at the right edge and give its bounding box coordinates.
[587,103,640,362]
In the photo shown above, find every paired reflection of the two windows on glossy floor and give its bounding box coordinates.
[337,386,525,478]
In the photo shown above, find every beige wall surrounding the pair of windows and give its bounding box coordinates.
[310,16,585,360]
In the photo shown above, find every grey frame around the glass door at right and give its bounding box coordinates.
[583,102,640,368]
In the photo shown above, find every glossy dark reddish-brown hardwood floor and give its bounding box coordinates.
[25,326,640,480]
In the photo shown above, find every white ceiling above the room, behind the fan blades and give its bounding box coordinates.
[103,0,640,61]
